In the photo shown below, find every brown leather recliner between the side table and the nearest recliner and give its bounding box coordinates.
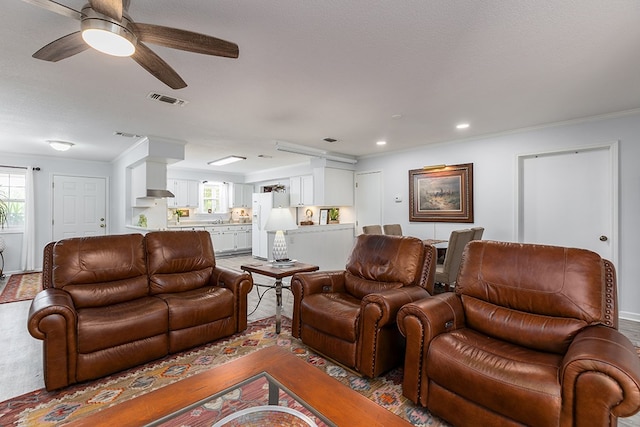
[291,234,436,377]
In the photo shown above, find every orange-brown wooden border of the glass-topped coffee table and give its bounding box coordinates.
[68,346,411,427]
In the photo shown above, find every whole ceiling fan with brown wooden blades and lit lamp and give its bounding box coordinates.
[23,0,238,89]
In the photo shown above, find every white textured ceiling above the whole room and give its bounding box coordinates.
[0,0,640,173]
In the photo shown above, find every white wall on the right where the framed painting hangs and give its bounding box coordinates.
[357,112,640,321]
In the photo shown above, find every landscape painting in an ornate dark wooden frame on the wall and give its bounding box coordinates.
[409,163,473,223]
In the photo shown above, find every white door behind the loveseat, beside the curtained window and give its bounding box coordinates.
[53,175,107,240]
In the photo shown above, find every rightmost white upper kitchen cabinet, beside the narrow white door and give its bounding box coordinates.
[313,167,354,206]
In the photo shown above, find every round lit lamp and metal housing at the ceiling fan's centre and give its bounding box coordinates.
[80,7,138,56]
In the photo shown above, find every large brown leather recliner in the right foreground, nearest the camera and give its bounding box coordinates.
[398,241,640,427]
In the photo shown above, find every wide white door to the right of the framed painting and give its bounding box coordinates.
[518,143,618,262]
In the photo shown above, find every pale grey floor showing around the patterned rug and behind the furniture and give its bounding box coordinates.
[0,255,640,427]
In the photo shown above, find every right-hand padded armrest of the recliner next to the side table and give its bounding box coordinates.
[361,286,430,326]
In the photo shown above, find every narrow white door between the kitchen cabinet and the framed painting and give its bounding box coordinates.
[355,171,382,235]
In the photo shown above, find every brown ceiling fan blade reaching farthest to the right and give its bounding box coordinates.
[131,22,239,58]
